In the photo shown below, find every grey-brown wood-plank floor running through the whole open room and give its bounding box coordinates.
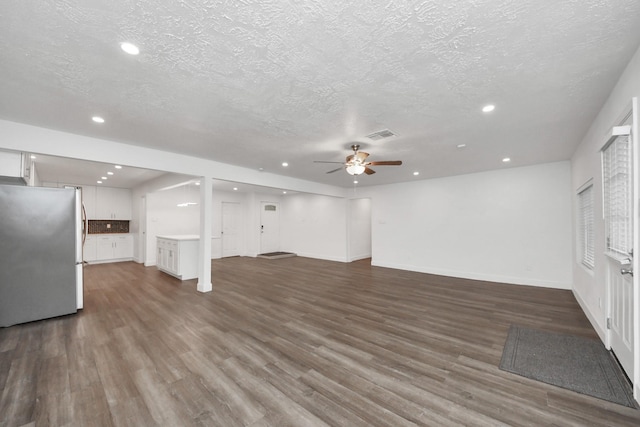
[0,257,640,427]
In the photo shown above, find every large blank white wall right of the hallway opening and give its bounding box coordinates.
[360,162,573,289]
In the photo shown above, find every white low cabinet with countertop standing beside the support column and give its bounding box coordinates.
[156,235,200,280]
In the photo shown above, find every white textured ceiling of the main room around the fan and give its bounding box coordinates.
[0,0,640,186]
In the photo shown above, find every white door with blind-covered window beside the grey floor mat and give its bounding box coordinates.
[603,109,638,379]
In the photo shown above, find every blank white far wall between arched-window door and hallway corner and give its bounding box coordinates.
[280,193,347,262]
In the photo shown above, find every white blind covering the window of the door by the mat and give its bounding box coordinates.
[602,136,633,257]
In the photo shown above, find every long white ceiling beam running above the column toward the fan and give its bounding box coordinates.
[0,120,346,197]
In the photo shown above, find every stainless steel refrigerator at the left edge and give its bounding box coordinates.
[0,185,84,327]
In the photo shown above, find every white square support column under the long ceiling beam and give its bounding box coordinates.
[197,176,213,292]
